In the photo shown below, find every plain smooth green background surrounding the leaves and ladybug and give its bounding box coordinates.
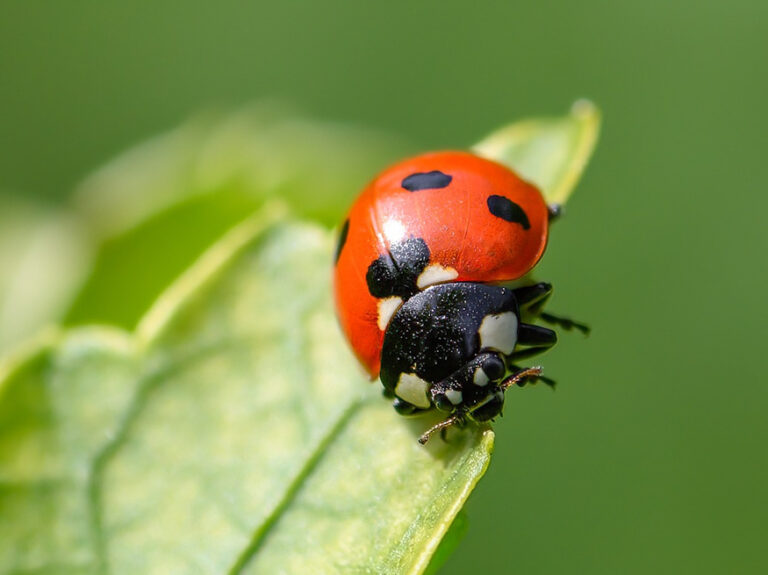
[0,0,768,574]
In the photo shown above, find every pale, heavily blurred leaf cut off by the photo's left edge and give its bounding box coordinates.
[0,196,90,353]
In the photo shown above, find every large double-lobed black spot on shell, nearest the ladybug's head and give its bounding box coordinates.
[365,238,429,299]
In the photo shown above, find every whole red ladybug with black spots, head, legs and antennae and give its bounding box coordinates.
[334,151,588,444]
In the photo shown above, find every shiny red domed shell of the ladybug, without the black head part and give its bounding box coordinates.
[334,152,549,377]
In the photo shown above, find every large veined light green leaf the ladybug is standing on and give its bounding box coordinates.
[0,215,493,574]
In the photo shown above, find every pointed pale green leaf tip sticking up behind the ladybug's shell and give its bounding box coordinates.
[473,100,600,204]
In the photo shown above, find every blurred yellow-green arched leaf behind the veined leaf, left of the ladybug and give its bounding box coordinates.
[76,105,412,235]
